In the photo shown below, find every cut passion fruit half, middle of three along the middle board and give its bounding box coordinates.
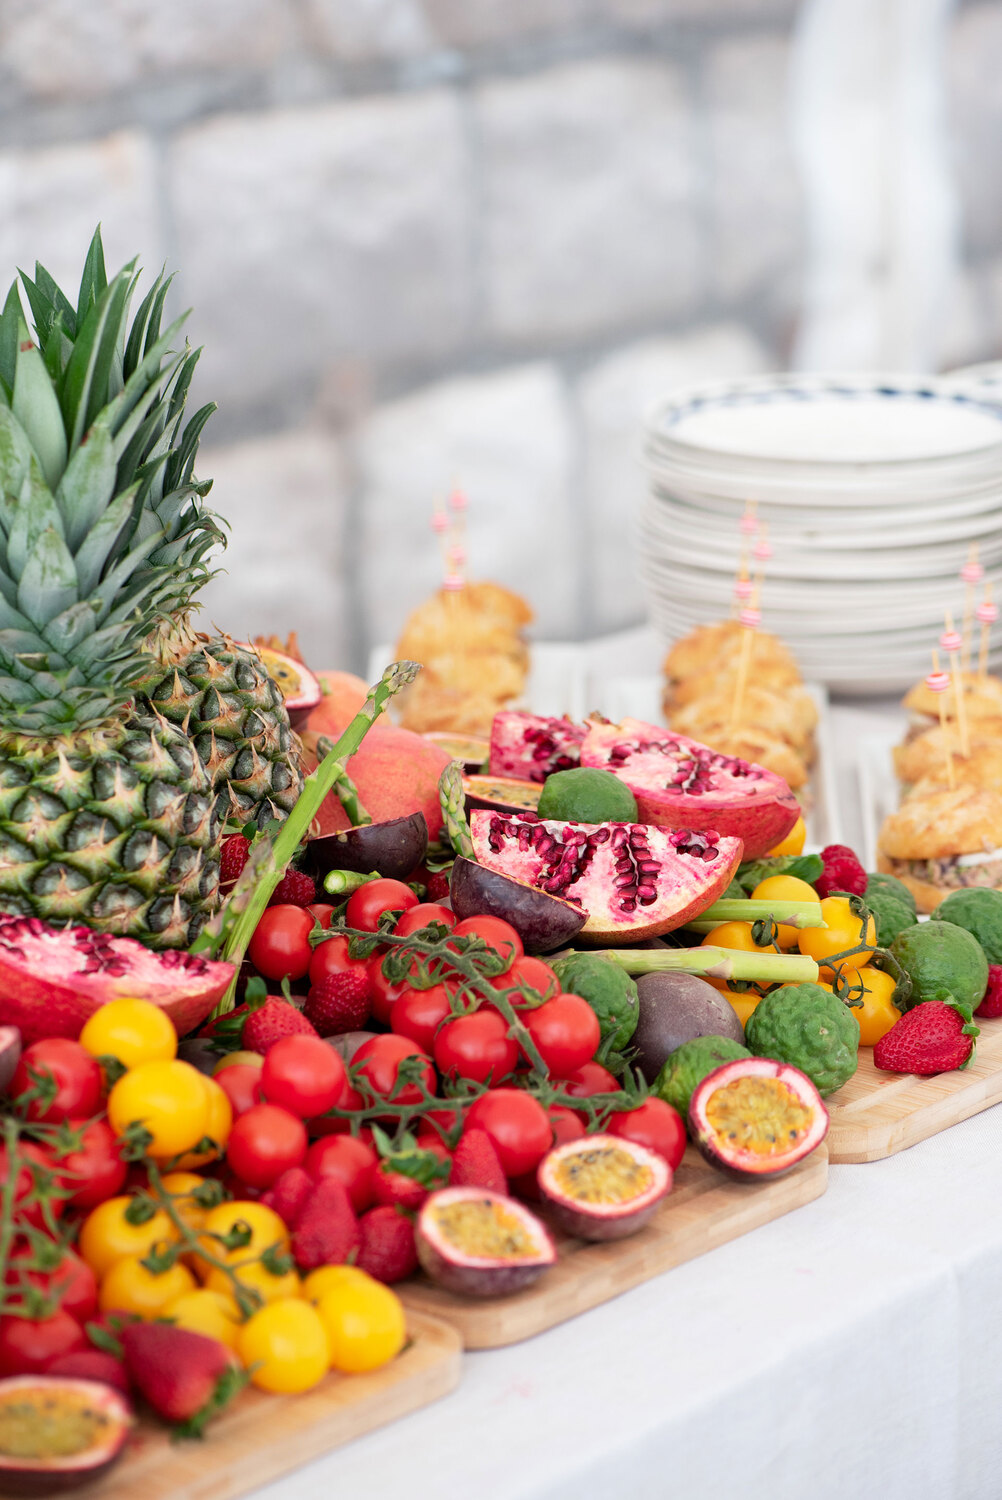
[539,1136,672,1239]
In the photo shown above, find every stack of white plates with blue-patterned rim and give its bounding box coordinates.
[635,375,1002,693]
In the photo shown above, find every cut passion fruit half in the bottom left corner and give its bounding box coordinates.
[0,1376,134,1496]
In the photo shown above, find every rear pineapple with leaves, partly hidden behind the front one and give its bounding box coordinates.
[23,240,303,827]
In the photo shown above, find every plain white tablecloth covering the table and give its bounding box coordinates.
[258,707,1002,1500]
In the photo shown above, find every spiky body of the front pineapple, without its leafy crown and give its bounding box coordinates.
[0,714,221,948]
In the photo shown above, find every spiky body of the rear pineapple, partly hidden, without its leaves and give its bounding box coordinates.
[147,635,303,827]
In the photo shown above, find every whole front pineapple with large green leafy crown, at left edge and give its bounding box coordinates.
[0,246,221,948]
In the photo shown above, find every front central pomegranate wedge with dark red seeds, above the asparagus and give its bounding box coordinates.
[470,812,741,944]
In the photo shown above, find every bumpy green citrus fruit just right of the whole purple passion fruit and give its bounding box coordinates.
[744,984,860,1097]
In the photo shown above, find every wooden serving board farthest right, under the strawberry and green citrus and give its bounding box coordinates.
[825,1019,1002,1163]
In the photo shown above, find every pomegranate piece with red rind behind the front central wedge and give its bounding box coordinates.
[581,719,801,860]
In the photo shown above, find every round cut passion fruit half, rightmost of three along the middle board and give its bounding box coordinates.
[689,1058,828,1181]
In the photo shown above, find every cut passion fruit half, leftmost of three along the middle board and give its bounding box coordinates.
[416,1187,557,1298]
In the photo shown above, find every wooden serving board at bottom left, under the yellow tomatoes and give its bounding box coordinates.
[74,1310,462,1500]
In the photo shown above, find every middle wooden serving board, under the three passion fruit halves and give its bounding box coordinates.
[398,1146,828,1349]
